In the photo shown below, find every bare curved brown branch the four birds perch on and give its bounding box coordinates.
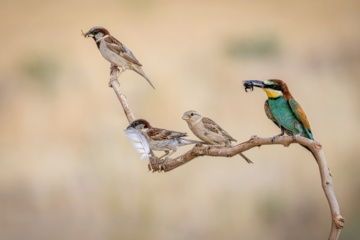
[111,69,345,240]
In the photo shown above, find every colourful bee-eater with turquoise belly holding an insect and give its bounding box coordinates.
[244,79,314,142]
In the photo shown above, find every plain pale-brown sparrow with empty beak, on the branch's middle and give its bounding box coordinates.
[182,111,253,163]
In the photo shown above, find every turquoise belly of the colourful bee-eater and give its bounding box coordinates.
[269,97,307,135]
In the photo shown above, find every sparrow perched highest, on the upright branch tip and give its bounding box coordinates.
[84,27,155,89]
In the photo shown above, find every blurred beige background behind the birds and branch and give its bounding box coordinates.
[0,0,360,240]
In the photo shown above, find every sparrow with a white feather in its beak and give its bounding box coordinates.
[127,119,205,159]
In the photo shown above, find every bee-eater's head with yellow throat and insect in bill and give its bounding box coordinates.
[244,79,288,98]
